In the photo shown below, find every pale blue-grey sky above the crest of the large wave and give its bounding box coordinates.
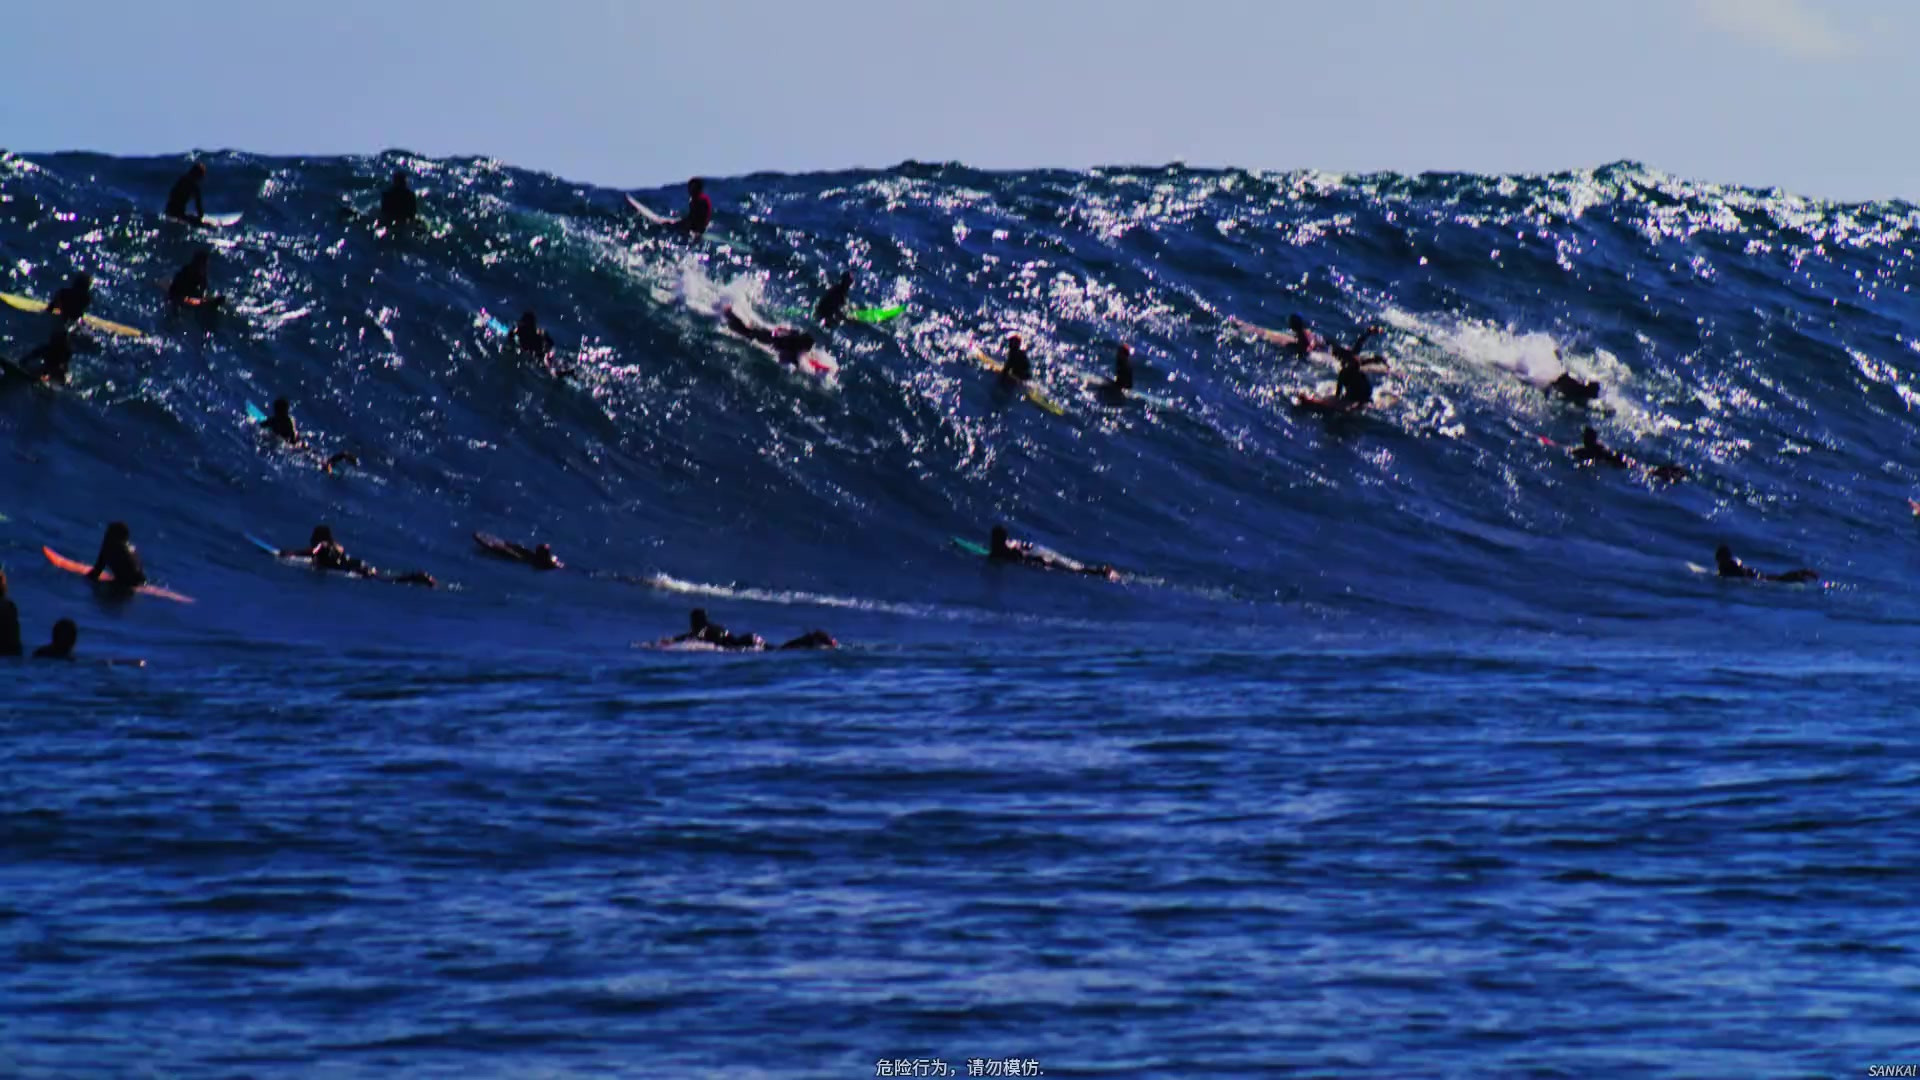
[0,0,1920,198]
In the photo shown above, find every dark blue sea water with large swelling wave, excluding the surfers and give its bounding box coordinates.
[0,154,1920,1076]
